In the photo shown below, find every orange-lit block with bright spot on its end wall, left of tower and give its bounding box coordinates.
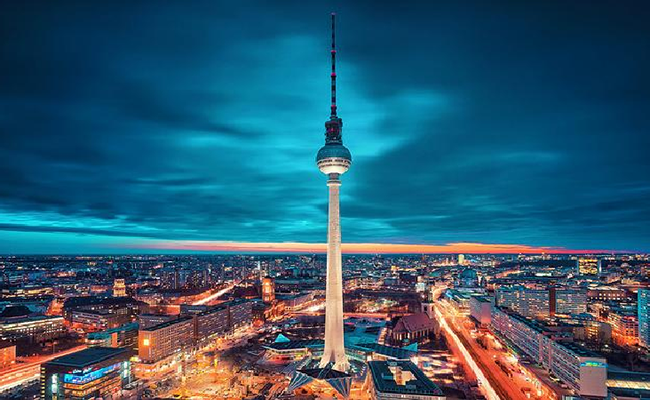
[138,316,195,363]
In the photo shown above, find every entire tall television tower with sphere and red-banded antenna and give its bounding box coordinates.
[316,13,352,372]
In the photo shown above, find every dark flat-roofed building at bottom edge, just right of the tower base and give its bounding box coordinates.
[366,361,446,400]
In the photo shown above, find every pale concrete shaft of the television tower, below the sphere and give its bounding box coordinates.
[320,174,349,371]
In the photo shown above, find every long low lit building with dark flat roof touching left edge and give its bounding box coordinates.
[0,315,67,343]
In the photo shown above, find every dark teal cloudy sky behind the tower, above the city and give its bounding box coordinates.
[0,1,650,253]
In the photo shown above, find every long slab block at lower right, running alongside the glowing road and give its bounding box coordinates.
[491,307,607,398]
